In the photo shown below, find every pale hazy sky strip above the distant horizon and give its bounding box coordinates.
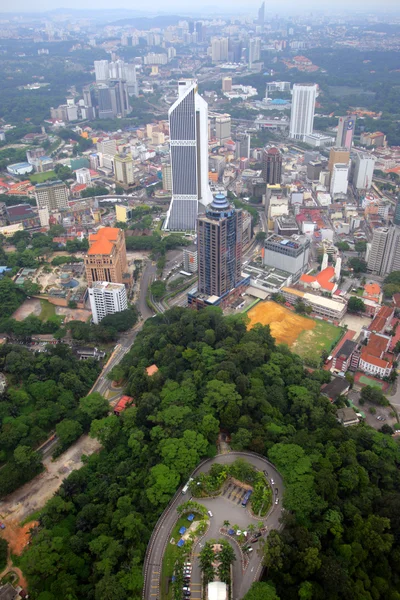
[0,0,400,15]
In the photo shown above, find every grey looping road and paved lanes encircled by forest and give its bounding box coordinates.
[143,452,284,600]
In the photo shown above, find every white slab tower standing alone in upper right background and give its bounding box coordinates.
[289,83,317,141]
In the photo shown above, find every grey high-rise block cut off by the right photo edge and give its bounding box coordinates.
[368,225,400,277]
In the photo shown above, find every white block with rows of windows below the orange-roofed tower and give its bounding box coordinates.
[88,281,128,325]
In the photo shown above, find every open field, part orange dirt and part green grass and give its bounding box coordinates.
[247,301,343,366]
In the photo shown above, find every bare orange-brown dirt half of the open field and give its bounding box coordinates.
[247,302,315,346]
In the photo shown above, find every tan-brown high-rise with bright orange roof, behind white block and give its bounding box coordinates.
[85,227,127,287]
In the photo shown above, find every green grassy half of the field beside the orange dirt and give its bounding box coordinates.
[291,320,344,359]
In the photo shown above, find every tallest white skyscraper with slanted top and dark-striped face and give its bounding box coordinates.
[164,79,212,231]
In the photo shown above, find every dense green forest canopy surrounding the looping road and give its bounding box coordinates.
[21,308,400,600]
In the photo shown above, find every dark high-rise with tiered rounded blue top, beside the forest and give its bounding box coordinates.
[197,194,243,296]
